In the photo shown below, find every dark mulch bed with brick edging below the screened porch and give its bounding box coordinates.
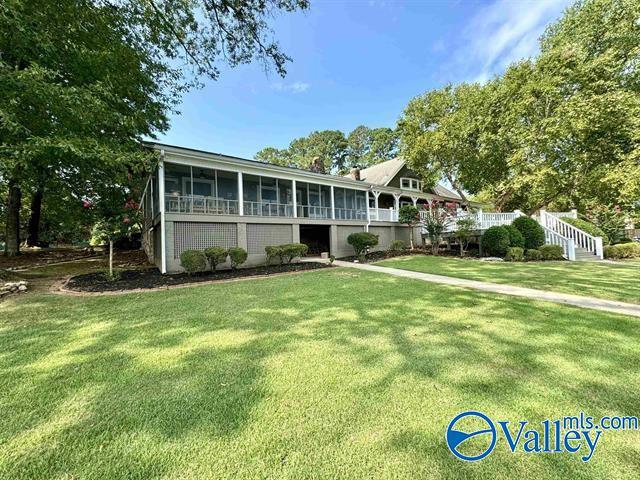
[65,262,330,292]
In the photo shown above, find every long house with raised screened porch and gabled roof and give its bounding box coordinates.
[141,143,465,273]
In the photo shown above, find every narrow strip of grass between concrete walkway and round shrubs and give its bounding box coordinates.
[378,255,640,303]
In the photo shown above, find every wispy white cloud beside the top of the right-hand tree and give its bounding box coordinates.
[447,0,573,82]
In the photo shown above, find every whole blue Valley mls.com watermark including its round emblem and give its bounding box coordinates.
[445,410,640,462]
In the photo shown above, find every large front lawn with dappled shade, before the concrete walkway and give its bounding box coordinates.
[0,268,640,479]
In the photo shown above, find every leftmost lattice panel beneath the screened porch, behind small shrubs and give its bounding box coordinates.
[173,222,238,258]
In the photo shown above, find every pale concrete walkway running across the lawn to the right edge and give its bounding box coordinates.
[333,260,640,317]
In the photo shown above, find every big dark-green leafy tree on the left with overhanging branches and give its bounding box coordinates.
[0,0,308,255]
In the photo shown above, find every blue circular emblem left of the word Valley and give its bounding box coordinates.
[445,411,497,462]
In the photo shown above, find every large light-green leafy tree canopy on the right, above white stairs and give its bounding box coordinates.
[399,0,640,211]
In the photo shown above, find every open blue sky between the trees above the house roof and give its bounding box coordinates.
[159,0,571,158]
